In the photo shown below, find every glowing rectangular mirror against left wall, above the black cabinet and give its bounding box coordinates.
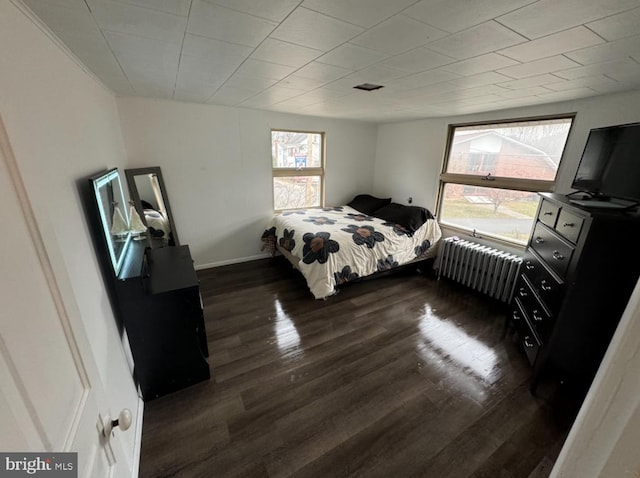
[89,168,131,275]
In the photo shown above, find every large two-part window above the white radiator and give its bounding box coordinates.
[438,116,573,244]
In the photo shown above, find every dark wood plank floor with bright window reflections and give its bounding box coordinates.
[140,258,570,478]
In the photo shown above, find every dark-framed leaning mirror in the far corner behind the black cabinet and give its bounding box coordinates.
[124,167,180,247]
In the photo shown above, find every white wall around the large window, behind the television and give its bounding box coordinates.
[374,92,640,212]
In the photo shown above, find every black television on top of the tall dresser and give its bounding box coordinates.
[571,123,640,201]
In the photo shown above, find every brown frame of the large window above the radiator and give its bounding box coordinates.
[436,112,576,249]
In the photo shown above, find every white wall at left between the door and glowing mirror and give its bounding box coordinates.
[0,1,138,462]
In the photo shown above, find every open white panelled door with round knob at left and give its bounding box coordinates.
[0,115,132,477]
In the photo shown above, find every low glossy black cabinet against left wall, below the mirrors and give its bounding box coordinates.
[114,243,210,400]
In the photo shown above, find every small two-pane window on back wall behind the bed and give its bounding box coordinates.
[271,130,325,211]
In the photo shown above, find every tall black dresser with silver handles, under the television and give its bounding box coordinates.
[510,193,640,399]
